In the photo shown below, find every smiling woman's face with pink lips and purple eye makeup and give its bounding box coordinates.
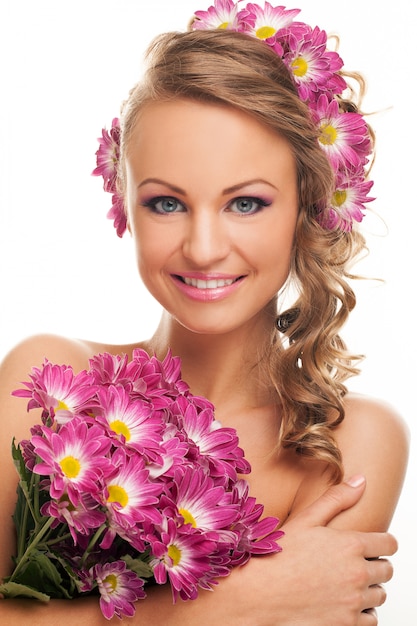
[126,99,298,333]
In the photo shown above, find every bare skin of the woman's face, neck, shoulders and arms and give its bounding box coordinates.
[0,100,408,626]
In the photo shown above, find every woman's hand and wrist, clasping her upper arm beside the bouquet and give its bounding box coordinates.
[210,477,397,626]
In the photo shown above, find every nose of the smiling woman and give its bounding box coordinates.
[183,209,230,267]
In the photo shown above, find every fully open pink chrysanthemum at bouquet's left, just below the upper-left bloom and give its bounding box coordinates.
[32,417,111,506]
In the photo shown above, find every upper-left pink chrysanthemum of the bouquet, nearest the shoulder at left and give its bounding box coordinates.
[13,361,95,424]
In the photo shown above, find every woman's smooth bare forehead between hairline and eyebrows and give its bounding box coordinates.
[127,99,295,185]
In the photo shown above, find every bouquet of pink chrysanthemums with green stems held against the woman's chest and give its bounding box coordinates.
[0,349,283,619]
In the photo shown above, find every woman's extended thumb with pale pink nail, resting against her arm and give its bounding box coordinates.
[288,476,366,528]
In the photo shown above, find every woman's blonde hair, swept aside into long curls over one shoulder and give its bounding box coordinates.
[119,30,372,481]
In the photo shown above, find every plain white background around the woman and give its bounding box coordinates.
[0,0,417,626]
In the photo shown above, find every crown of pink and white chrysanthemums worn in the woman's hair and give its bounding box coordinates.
[93,0,374,237]
